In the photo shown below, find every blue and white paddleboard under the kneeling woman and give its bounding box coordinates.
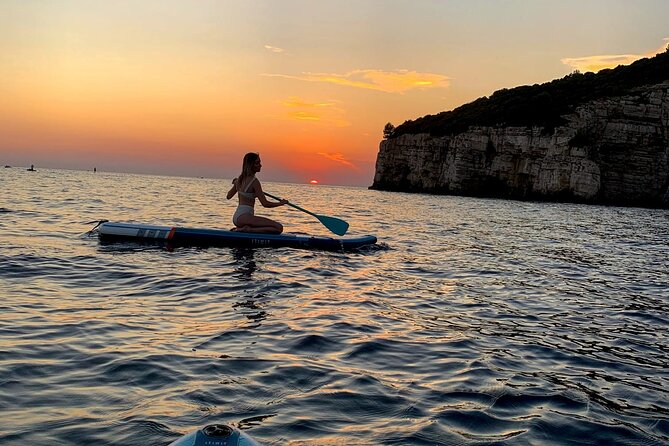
[96,222,376,251]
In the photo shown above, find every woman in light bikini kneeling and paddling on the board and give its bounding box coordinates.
[227,153,288,234]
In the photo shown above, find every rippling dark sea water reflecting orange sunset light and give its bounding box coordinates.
[0,168,669,446]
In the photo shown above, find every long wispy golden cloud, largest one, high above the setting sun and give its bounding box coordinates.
[263,70,450,93]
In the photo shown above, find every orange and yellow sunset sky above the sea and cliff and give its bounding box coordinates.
[0,0,669,186]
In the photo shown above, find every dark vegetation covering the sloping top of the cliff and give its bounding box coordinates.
[383,46,669,138]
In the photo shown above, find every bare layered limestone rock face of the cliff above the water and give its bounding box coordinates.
[371,83,669,208]
